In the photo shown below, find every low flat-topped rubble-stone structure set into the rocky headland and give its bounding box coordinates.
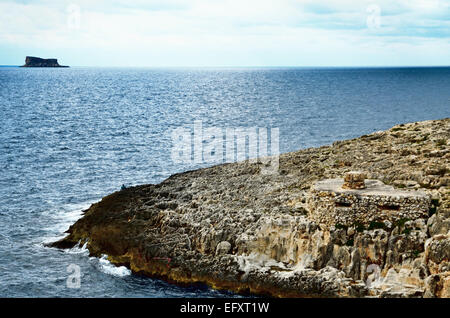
[307,179,431,226]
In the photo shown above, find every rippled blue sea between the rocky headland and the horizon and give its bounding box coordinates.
[0,67,450,297]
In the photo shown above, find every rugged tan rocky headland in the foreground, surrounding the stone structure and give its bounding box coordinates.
[52,119,450,297]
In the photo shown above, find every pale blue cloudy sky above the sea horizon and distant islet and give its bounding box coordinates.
[0,0,450,67]
